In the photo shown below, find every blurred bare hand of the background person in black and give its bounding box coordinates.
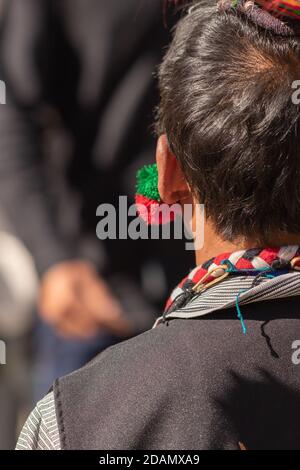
[39,261,133,338]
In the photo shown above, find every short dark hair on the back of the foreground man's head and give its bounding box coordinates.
[157,1,300,243]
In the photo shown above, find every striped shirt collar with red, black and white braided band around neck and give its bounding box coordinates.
[154,246,300,332]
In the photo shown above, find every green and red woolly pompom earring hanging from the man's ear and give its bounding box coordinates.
[135,163,180,225]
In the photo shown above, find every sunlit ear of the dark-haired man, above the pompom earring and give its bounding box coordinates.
[156,134,190,204]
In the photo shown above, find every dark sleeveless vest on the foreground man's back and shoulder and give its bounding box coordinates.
[54,297,300,450]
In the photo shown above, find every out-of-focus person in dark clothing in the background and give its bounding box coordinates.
[0,0,192,446]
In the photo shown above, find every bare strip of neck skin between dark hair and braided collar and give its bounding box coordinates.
[193,214,300,266]
